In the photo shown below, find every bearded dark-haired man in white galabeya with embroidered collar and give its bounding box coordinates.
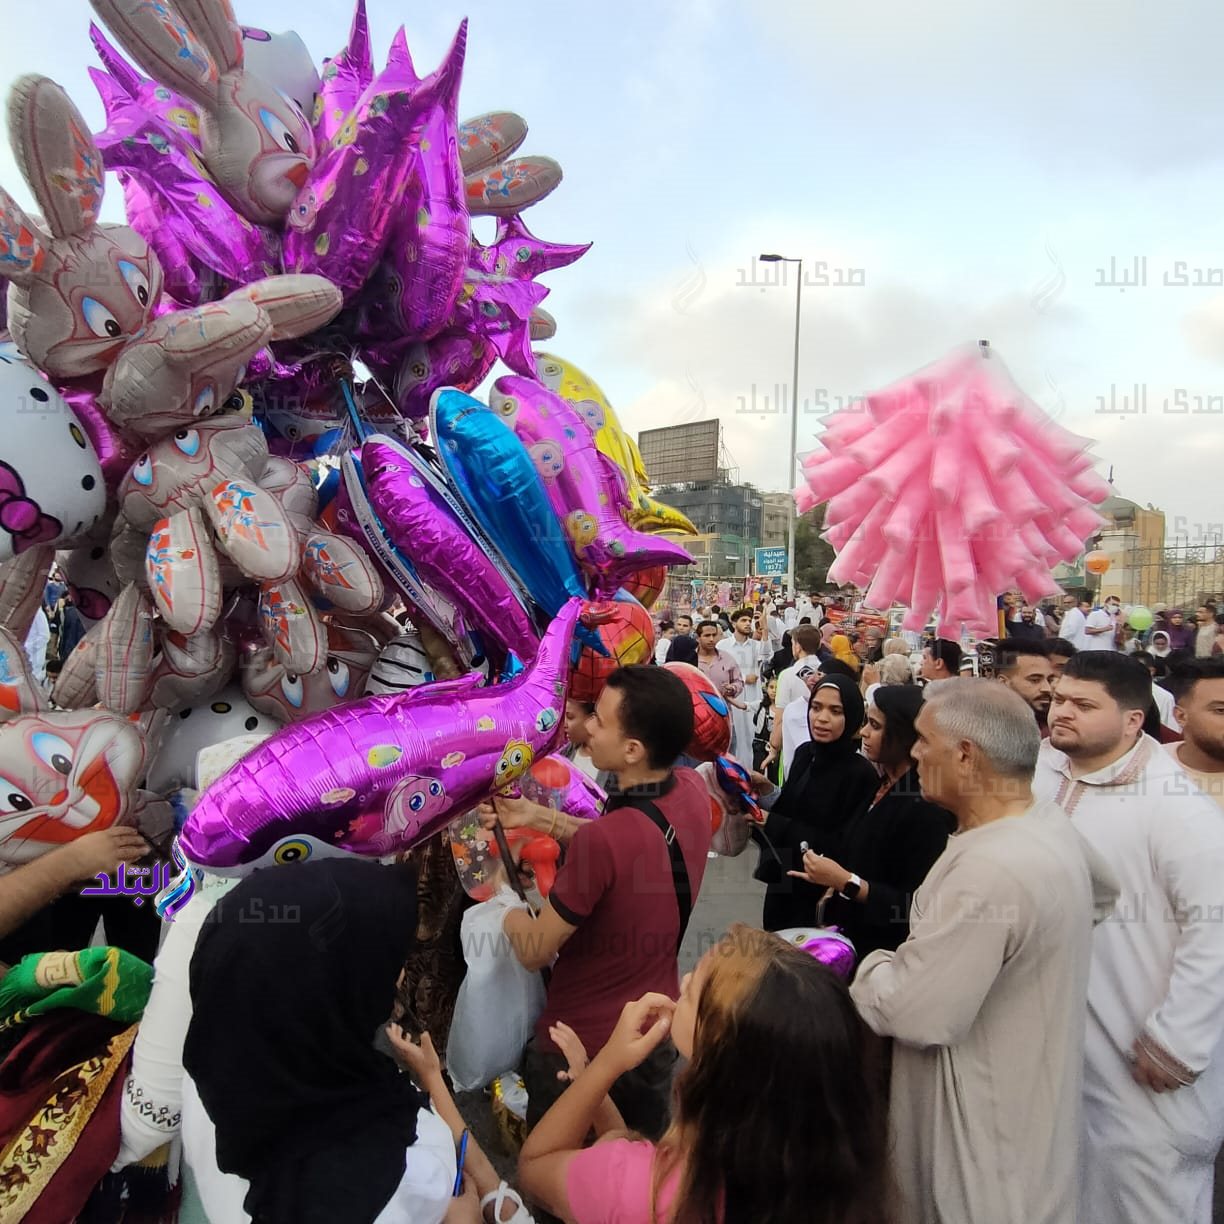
[1034,651,1224,1224]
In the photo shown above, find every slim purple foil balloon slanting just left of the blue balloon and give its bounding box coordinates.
[361,436,539,660]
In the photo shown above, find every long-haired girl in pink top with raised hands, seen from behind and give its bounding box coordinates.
[519,925,894,1224]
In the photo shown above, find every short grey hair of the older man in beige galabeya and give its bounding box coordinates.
[924,677,1042,778]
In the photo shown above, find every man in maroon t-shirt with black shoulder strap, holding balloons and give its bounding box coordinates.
[504,666,710,1138]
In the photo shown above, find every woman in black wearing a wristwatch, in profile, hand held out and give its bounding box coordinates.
[788,684,956,961]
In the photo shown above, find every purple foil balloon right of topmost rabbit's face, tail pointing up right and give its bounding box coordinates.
[284,21,468,301]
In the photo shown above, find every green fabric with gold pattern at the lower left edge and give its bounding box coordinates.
[0,947,153,1032]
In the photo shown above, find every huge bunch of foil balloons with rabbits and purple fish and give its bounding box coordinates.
[0,0,694,886]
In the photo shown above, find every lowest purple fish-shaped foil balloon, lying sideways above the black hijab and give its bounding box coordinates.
[179,600,581,875]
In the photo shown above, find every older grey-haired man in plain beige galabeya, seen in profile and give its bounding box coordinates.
[851,679,1116,1224]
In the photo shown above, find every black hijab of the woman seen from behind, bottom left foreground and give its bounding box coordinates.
[182,858,425,1224]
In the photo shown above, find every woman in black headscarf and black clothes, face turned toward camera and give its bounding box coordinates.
[753,676,879,930]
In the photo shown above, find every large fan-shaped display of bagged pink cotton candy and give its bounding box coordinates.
[794,345,1109,638]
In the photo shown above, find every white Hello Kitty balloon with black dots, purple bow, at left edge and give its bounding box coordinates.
[0,344,106,561]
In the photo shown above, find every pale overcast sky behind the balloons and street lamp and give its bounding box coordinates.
[0,0,1224,536]
